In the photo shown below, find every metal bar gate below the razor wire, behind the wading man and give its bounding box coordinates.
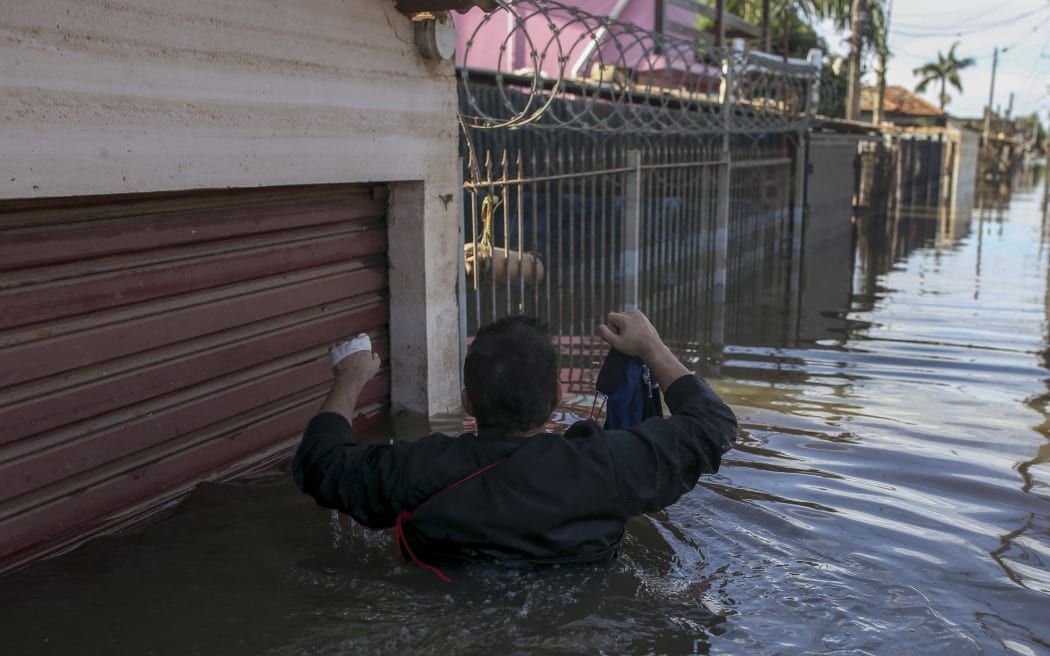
[461,129,801,393]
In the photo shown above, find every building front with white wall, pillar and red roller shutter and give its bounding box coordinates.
[0,0,461,568]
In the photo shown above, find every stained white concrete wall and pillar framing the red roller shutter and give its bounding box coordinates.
[0,0,461,414]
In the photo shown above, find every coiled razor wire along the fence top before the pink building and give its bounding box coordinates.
[458,0,820,133]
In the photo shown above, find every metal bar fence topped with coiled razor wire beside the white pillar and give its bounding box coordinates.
[460,0,820,390]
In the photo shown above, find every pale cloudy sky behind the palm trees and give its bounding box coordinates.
[818,0,1050,123]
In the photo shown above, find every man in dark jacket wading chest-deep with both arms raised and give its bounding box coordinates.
[293,311,737,578]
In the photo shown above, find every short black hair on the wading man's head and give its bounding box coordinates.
[463,316,559,432]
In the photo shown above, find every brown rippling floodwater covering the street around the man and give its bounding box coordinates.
[0,171,1050,655]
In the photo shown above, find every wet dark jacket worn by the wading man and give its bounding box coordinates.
[293,375,737,563]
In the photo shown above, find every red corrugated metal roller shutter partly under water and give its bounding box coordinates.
[0,181,390,569]
